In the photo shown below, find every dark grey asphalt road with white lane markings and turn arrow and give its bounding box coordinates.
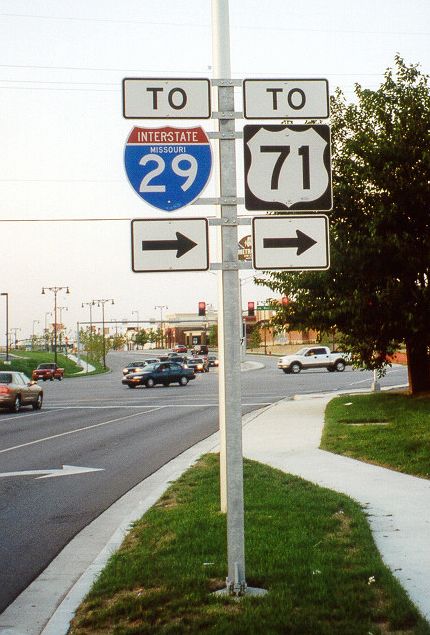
[0,353,407,612]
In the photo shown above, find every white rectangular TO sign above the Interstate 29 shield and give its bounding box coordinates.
[122,77,211,119]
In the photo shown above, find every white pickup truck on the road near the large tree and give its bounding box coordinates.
[278,346,350,374]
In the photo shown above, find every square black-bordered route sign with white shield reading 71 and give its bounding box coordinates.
[243,125,332,211]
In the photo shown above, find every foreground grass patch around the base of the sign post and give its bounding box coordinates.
[69,454,430,635]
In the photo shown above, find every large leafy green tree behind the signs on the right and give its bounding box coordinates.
[260,56,430,393]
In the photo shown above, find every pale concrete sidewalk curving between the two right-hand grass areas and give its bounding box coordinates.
[243,395,430,620]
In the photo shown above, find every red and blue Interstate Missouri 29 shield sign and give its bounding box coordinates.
[124,126,212,212]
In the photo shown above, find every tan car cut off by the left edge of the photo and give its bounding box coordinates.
[0,371,43,412]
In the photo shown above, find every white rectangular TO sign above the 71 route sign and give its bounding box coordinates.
[243,79,329,119]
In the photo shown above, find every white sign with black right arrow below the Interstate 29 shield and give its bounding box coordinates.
[131,218,209,273]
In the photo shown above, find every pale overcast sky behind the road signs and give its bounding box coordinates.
[0,0,430,344]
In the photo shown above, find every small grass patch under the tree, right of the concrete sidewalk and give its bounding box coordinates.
[320,392,430,478]
